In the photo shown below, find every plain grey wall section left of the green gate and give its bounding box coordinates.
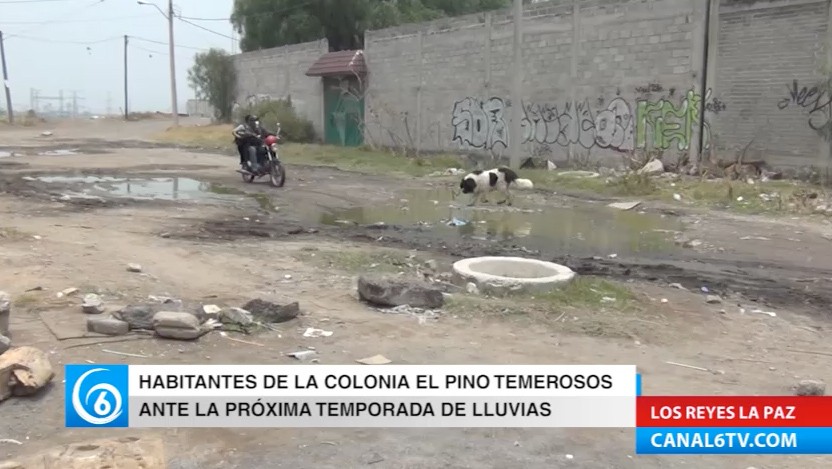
[234,39,329,135]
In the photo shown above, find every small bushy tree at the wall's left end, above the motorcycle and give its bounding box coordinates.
[188,49,237,122]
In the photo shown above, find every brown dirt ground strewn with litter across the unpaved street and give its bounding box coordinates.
[0,121,832,469]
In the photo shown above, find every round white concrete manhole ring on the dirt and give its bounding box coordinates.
[453,256,576,293]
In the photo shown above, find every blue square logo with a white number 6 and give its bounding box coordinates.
[64,365,129,428]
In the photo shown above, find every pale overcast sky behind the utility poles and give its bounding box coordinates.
[0,0,236,113]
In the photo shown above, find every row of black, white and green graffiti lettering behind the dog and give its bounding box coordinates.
[451,90,726,151]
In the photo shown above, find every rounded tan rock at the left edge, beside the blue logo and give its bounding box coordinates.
[0,347,55,401]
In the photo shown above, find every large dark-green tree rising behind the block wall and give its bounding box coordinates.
[231,0,511,51]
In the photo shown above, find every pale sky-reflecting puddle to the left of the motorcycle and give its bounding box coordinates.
[24,176,232,200]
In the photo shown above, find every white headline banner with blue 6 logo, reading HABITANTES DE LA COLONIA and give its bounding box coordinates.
[65,365,639,428]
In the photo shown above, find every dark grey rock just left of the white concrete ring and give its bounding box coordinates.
[358,276,445,309]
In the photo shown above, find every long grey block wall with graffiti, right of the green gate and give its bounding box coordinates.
[365,0,706,165]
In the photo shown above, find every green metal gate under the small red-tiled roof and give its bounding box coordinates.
[324,78,364,147]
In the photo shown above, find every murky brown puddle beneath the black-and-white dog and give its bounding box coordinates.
[317,187,683,255]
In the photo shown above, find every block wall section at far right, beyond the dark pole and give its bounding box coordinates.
[708,0,832,167]
